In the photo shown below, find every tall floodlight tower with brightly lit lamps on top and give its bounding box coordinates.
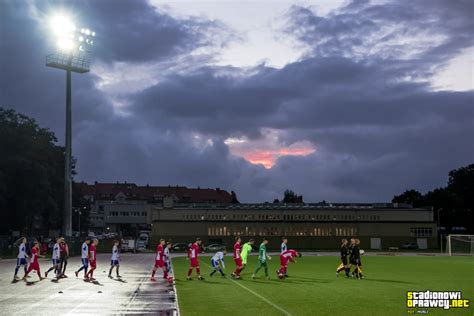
[46,15,95,237]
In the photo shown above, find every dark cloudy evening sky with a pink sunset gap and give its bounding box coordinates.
[0,0,474,202]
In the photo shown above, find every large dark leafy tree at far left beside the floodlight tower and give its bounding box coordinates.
[0,108,70,234]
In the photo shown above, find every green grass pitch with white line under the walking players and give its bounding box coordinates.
[173,255,474,316]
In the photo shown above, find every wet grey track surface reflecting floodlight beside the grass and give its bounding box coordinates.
[0,254,178,315]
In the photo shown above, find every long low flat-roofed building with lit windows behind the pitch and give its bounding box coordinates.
[151,200,438,250]
